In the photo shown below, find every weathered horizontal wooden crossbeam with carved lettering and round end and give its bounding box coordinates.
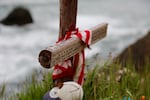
[39,23,107,68]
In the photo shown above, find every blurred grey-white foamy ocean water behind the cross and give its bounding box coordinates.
[0,0,150,94]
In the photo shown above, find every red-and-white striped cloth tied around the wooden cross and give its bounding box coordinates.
[52,28,92,85]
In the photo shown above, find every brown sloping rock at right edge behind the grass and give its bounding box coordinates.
[117,31,150,72]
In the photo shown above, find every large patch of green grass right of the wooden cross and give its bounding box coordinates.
[83,64,150,100]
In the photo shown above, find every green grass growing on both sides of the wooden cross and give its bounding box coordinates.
[2,60,150,100]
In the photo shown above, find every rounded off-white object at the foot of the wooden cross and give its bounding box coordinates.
[49,81,83,100]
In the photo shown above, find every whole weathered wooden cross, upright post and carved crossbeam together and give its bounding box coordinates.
[39,0,107,68]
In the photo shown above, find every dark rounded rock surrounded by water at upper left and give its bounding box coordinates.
[0,7,33,26]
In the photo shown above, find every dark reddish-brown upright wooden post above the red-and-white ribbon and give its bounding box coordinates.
[59,0,78,38]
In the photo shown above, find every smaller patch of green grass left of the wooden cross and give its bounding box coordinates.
[9,73,53,100]
